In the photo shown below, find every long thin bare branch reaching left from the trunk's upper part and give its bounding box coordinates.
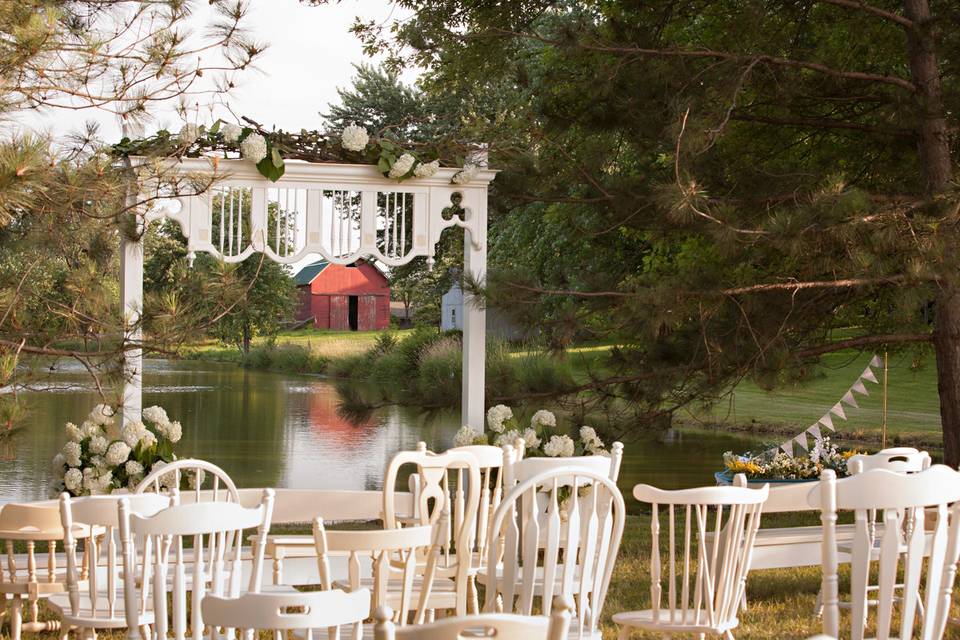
[476,29,917,93]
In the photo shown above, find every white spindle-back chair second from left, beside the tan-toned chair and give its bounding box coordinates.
[50,493,171,636]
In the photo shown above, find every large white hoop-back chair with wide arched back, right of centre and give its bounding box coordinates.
[477,467,625,638]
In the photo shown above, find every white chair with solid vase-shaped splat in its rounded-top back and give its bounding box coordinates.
[383,444,481,615]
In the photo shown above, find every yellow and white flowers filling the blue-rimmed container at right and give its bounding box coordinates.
[723,437,859,481]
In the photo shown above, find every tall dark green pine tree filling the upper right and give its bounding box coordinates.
[357,0,960,464]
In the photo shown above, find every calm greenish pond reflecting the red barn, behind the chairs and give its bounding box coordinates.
[0,360,764,503]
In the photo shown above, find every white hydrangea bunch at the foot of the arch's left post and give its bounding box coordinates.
[53,404,183,496]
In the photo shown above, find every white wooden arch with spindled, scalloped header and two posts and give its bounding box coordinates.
[121,158,496,430]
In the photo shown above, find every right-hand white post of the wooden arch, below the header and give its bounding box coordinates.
[460,189,487,431]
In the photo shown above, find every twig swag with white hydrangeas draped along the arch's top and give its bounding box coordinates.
[110,120,479,184]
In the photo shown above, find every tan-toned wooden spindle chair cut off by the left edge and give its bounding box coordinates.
[0,502,80,640]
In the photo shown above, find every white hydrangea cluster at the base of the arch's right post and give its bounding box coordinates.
[453,404,610,458]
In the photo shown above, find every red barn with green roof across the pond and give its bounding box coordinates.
[293,260,390,331]
